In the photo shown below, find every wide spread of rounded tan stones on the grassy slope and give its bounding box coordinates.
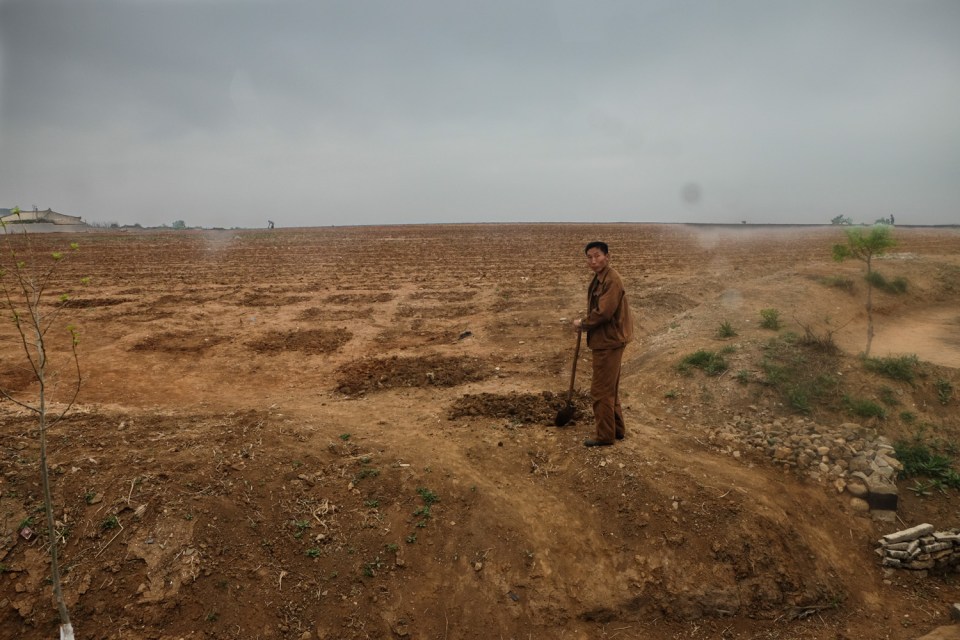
[709,415,903,520]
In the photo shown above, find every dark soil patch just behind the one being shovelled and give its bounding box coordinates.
[337,355,493,395]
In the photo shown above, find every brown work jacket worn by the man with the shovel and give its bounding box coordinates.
[580,267,633,349]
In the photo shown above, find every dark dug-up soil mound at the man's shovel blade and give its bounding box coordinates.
[448,391,590,424]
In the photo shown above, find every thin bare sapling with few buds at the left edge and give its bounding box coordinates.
[0,207,85,640]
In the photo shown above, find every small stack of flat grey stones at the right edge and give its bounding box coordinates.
[876,524,960,571]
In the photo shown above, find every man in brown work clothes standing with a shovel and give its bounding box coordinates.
[573,241,633,447]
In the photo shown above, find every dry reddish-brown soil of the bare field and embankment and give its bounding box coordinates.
[0,224,960,640]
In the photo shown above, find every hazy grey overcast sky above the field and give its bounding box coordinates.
[0,0,960,227]
